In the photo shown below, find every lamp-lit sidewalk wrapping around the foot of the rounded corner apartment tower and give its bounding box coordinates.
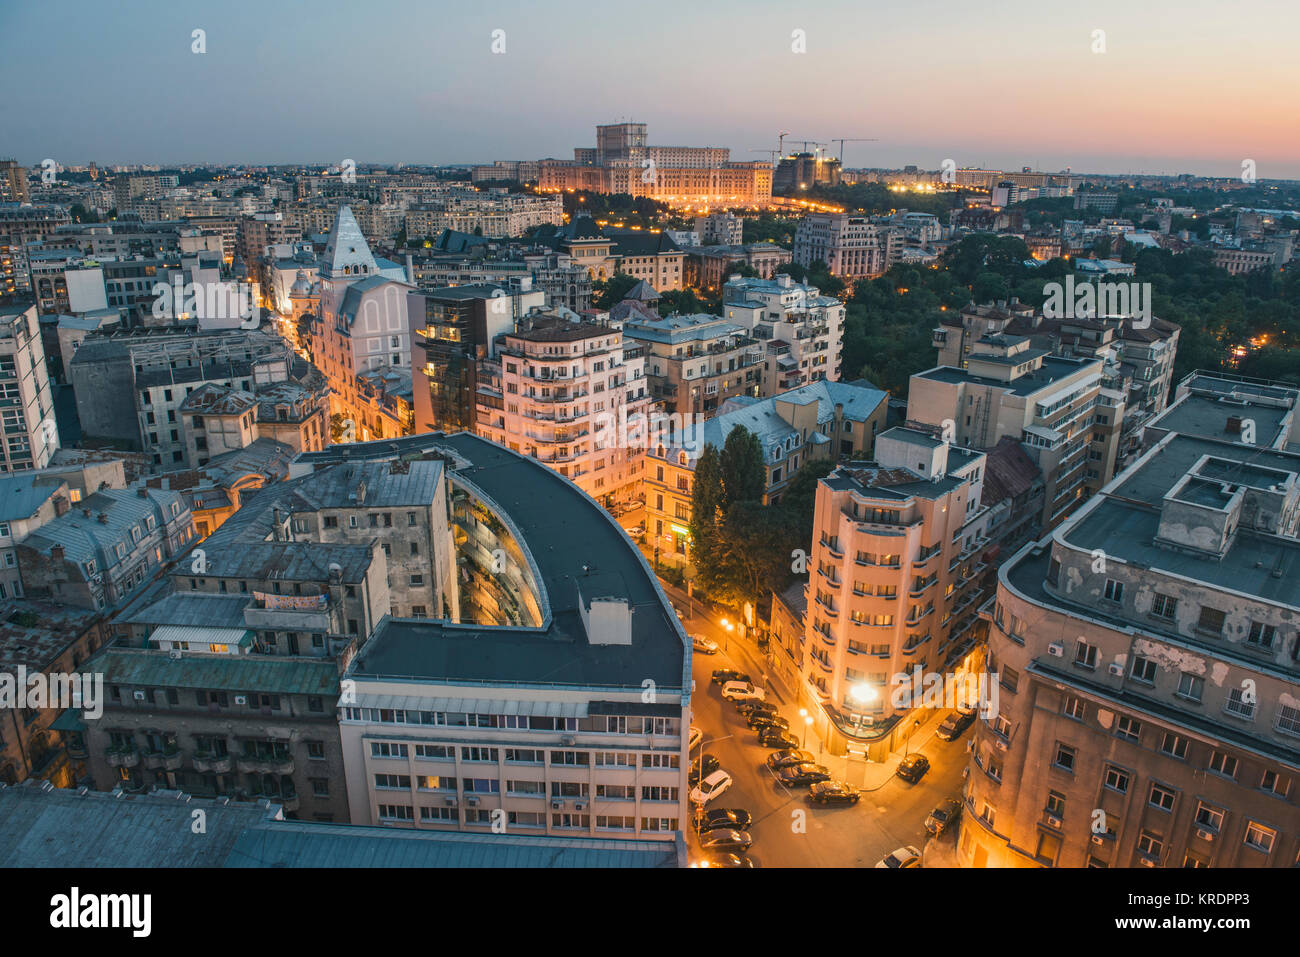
[659,579,948,791]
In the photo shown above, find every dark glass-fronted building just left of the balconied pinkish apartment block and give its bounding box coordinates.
[410,277,546,433]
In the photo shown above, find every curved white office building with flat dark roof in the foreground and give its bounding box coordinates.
[339,434,690,841]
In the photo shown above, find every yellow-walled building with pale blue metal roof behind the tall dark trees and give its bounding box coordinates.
[645,380,889,564]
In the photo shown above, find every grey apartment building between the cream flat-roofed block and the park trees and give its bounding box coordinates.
[935,299,1182,477]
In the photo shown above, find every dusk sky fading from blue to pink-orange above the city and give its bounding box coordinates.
[0,0,1300,179]
